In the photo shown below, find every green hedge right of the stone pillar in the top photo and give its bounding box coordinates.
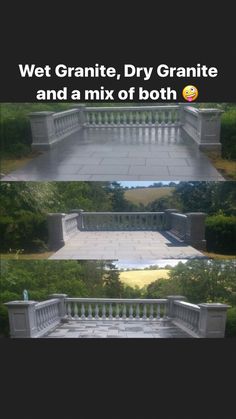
[221,109,236,159]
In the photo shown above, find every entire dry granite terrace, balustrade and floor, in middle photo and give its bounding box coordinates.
[48,209,205,261]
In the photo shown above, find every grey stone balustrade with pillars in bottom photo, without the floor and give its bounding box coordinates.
[5,294,229,338]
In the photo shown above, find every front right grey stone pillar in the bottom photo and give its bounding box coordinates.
[198,303,229,338]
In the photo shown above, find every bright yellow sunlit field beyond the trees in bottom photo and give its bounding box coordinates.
[120,269,169,288]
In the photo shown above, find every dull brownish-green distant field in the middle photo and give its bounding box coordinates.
[125,188,175,205]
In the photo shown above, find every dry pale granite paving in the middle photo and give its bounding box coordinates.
[50,231,205,261]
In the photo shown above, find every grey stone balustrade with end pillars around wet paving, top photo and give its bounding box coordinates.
[29,104,222,150]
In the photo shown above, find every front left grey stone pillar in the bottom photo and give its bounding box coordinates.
[4,301,37,338]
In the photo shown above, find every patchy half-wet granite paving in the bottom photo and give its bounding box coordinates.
[44,320,192,338]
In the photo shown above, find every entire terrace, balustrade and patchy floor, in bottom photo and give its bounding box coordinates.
[5,294,228,338]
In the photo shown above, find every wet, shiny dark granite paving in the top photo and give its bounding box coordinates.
[2,127,223,181]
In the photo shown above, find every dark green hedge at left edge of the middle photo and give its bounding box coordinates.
[0,211,48,252]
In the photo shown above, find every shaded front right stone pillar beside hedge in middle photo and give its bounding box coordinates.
[185,212,206,250]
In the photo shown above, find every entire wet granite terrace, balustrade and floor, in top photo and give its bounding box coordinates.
[2,106,223,181]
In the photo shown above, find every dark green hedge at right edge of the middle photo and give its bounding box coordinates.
[206,214,236,255]
